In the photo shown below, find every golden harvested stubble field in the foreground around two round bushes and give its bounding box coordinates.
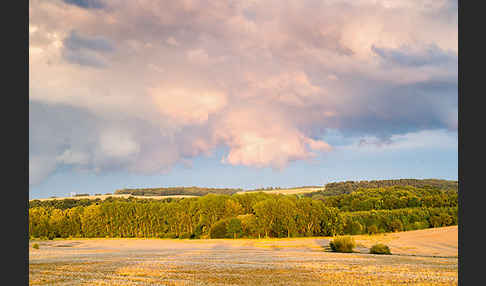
[29,226,458,285]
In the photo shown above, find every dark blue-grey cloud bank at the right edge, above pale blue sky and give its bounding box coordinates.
[329,81,457,139]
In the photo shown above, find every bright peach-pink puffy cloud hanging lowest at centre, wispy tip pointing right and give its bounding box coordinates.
[214,107,331,169]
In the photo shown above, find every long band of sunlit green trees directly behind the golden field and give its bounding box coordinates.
[29,182,458,239]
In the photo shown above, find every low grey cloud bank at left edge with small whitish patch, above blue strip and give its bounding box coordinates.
[29,100,213,185]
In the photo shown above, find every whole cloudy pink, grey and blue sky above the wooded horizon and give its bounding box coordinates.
[29,0,458,198]
